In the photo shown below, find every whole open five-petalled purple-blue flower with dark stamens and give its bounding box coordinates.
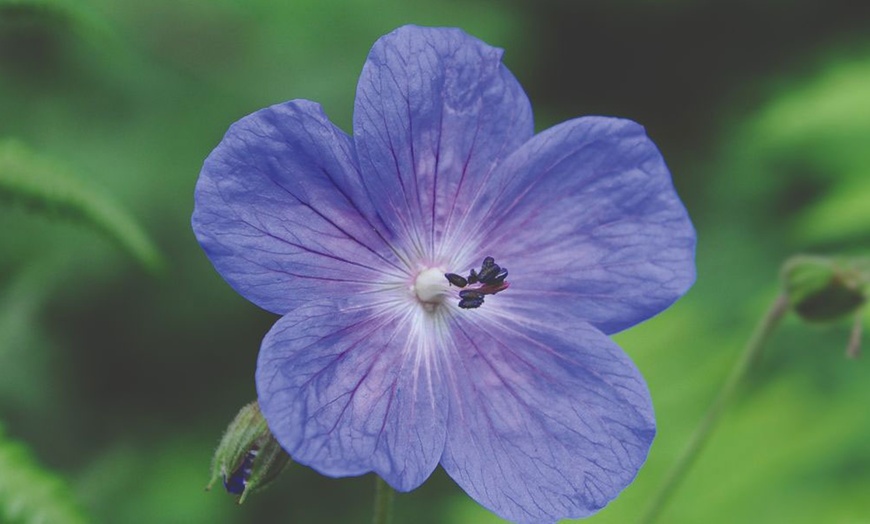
[193,26,695,522]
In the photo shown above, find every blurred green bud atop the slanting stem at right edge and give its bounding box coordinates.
[782,256,867,322]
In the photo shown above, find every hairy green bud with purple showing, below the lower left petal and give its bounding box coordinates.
[206,401,291,504]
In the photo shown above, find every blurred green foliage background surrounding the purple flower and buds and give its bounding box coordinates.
[0,0,870,524]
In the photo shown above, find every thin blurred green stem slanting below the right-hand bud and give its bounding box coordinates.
[638,296,789,524]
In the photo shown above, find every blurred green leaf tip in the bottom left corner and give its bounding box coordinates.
[0,429,90,524]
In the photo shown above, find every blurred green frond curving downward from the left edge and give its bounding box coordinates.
[0,140,163,272]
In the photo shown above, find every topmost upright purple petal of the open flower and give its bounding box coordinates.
[354,26,533,261]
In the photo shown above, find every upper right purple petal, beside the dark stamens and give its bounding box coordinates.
[480,117,695,333]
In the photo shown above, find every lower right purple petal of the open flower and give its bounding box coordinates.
[441,310,655,522]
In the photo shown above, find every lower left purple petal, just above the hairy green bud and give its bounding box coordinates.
[257,302,447,491]
